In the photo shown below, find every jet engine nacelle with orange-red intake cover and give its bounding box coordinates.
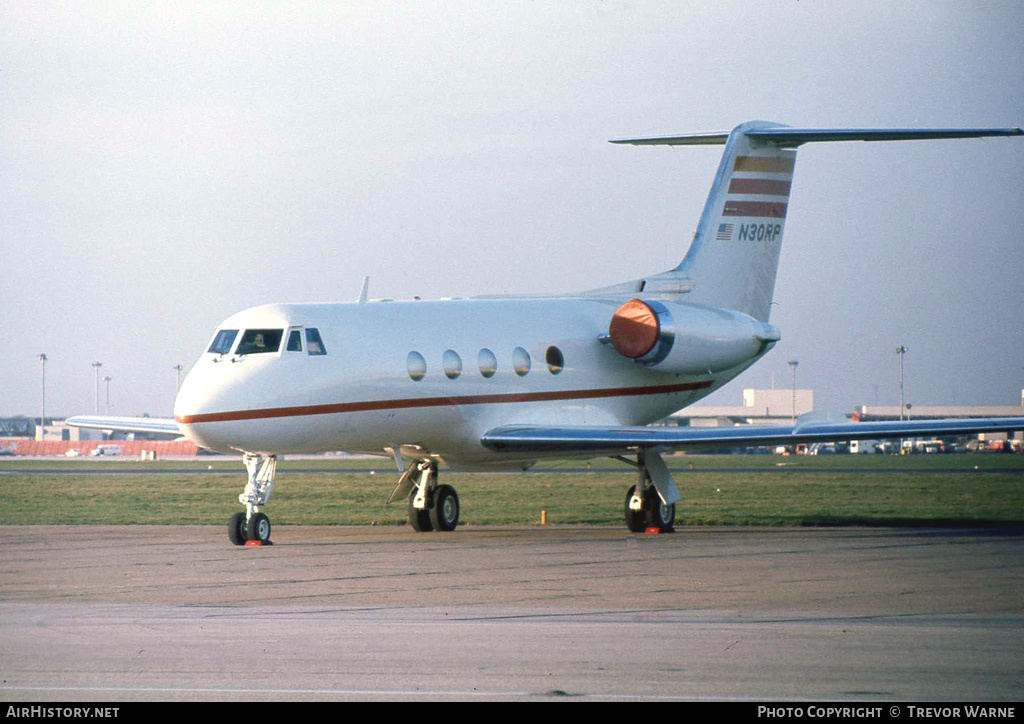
[601,299,781,375]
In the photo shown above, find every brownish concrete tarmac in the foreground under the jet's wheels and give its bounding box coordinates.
[0,525,1024,701]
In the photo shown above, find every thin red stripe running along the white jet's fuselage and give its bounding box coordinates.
[175,380,714,425]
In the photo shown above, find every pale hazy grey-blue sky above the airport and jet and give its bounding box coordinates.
[0,0,1024,416]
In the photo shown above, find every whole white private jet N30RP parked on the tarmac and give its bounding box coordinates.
[68,121,1024,545]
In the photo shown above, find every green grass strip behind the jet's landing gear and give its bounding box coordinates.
[0,455,1024,525]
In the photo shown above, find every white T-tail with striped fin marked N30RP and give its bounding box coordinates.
[596,121,1022,322]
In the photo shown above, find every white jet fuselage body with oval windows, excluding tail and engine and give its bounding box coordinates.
[174,297,766,466]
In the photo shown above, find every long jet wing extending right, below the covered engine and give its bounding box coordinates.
[480,417,1024,455]
